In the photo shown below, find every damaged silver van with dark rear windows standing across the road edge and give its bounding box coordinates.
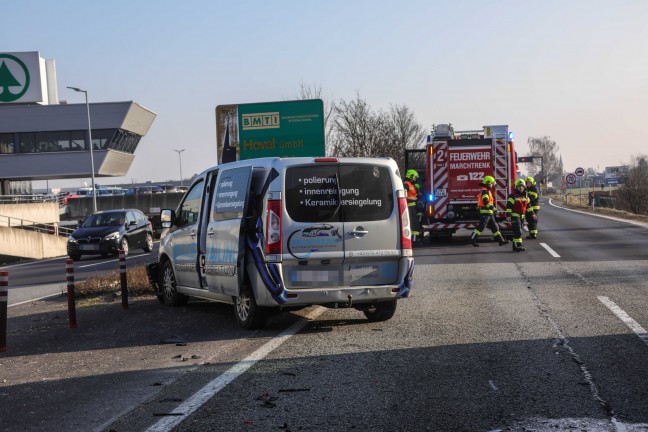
[147,157,414,329]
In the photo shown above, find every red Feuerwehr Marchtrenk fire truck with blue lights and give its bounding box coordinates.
[405,124,517,238]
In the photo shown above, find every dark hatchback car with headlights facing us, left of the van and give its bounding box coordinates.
[67,209,153,261]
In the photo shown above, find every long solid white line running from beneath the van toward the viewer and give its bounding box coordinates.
[146,306,326,432]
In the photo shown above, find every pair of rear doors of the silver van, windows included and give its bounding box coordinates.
[283,161,401,288]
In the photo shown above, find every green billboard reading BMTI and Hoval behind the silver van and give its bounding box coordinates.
[216,99,325,163]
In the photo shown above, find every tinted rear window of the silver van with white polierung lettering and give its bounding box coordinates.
[286,164,394,222]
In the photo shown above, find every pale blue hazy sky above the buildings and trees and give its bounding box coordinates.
[5,0,648,187]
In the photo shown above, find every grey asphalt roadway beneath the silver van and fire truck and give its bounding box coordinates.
[0,204,648,432]
